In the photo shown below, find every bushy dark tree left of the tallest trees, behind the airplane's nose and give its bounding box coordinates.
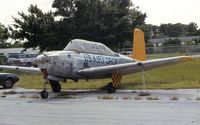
[10,5,56,52]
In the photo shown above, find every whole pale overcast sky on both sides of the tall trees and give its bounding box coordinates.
[0,0,200,27]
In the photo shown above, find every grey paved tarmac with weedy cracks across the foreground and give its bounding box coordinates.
[0,88,200,125]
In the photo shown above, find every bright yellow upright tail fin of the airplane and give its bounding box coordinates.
[129,28,146,61]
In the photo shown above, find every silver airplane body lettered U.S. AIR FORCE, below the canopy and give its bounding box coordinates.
[39,51,134,81]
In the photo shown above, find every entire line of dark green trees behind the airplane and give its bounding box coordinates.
[0,0,200,52]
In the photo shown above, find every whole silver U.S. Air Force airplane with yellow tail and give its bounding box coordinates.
[0,28,192,99]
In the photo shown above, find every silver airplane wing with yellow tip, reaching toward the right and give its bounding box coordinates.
[77,56,192,78]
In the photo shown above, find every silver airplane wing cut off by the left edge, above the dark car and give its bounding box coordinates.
[0,65,42,73]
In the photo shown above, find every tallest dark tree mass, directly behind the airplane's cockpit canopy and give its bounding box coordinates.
[52,0,146,48]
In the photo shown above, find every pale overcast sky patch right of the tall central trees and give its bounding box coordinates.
[132,0,200,27]
